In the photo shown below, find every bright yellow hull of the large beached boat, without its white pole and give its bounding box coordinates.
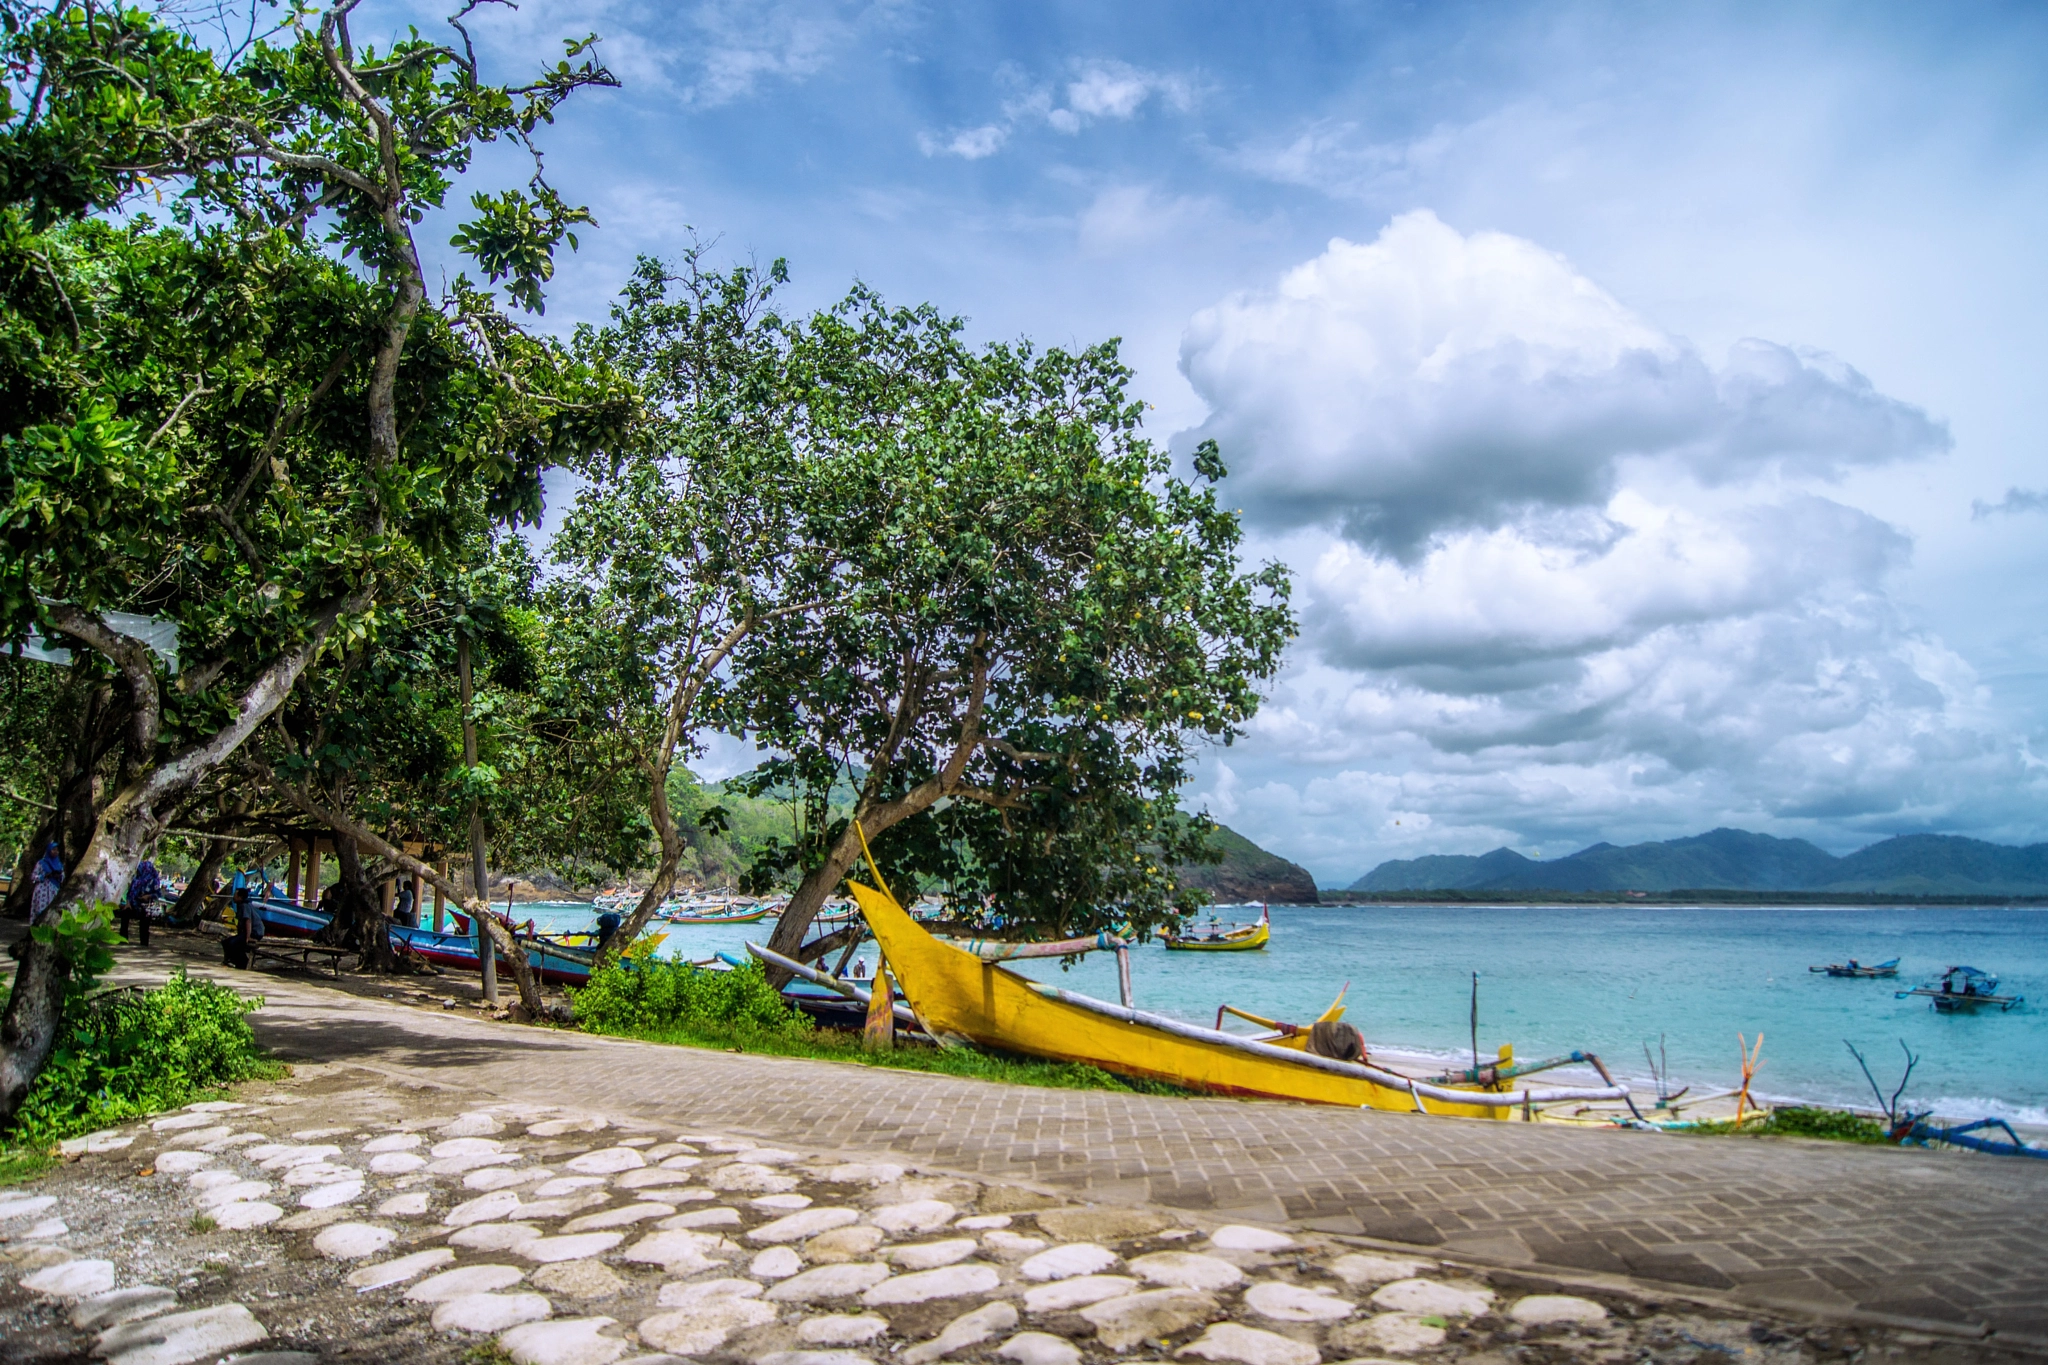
[852,882,1507,1119]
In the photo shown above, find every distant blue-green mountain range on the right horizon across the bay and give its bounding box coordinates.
[1352,829,2048,896]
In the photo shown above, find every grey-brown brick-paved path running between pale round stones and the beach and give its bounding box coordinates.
[127,952,2048,1342]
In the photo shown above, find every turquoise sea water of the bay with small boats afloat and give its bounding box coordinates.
[520,907,2048,1124]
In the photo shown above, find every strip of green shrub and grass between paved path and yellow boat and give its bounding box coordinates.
[573,958,1190,1095]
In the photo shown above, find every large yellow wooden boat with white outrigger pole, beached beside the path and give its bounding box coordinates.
[839,882,1628,1117]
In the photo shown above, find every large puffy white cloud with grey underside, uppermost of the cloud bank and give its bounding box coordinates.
[1182,211,1950,559]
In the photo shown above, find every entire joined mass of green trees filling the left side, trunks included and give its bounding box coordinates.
[0,0,1294,1124]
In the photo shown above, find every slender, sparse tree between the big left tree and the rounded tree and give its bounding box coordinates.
[551,253,846,952]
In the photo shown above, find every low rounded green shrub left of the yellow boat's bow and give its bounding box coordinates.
[569,958,811,1042]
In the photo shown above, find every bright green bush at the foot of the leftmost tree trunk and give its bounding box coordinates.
[6,972,276,1146]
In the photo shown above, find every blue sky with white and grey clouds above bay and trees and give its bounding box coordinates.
[387,0,2048,886]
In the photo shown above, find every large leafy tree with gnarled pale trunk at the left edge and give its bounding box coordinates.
[0,0,616,1124]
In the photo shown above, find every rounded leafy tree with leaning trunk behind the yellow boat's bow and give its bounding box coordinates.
[745,291,1292,956]
